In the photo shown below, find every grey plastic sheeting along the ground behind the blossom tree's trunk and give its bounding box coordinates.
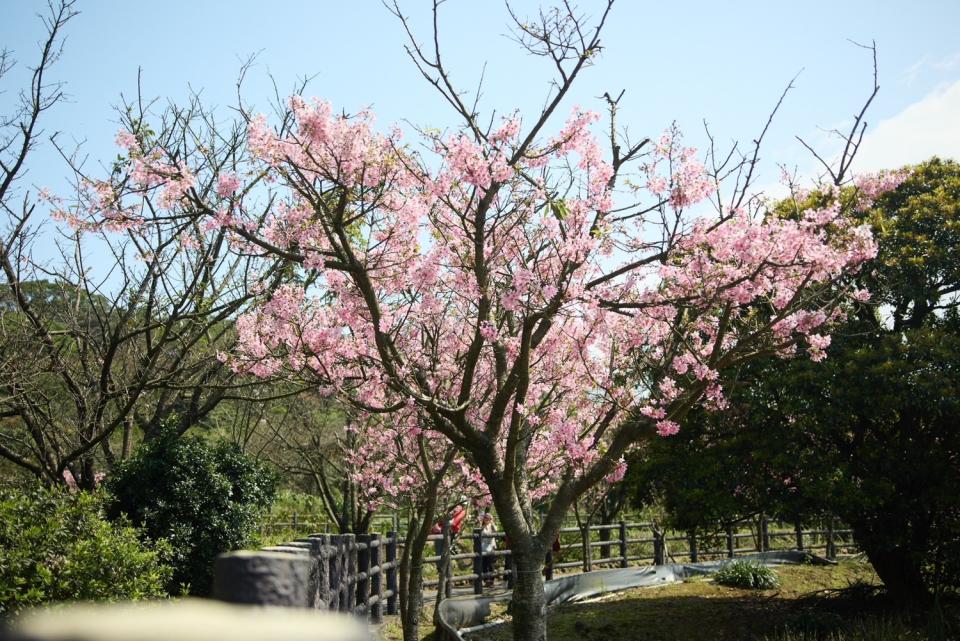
[439,550,834,641]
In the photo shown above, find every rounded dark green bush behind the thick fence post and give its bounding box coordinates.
[107,433,276,596]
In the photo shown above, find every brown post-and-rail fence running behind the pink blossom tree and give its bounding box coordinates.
[214,515,854,624]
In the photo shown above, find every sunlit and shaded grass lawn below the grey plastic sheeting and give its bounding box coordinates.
[383,561,952,641]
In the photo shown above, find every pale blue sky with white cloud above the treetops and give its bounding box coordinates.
[0,0,960,202]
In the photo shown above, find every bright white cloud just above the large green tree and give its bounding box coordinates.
[854,80,960,173]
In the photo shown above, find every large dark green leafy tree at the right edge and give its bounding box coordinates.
[632,159,960,603]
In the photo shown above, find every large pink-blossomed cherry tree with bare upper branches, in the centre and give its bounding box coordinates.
[77,2,900,640]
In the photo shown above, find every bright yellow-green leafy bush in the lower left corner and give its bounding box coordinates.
[0,487,172,617]
